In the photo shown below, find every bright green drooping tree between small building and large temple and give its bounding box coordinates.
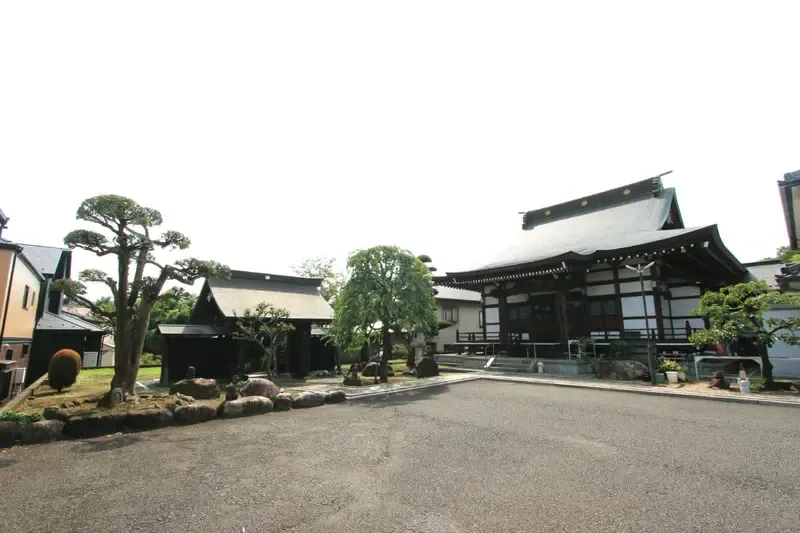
[330,246,437,383]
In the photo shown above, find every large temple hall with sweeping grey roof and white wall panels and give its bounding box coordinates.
[437,178,751,357]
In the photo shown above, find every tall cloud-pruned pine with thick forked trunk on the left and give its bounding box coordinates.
[54,194,229,393]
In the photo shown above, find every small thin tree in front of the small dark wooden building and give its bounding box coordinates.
[233,302,294,379]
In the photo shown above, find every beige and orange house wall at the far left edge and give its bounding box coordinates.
[0,240,44,403]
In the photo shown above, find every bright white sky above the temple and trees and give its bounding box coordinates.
[0,0,800,295]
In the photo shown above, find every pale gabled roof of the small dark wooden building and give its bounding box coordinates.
[206,270,333,321]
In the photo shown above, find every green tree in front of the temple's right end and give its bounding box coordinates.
[690,281,800,387]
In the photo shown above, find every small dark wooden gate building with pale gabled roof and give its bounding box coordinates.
[158,270,335,382]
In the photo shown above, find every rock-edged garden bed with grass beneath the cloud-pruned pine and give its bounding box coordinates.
[0,368,346,447]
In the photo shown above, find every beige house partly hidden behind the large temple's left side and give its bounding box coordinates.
[431,286,483,353]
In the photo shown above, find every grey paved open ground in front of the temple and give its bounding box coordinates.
[0,381,800,533]
